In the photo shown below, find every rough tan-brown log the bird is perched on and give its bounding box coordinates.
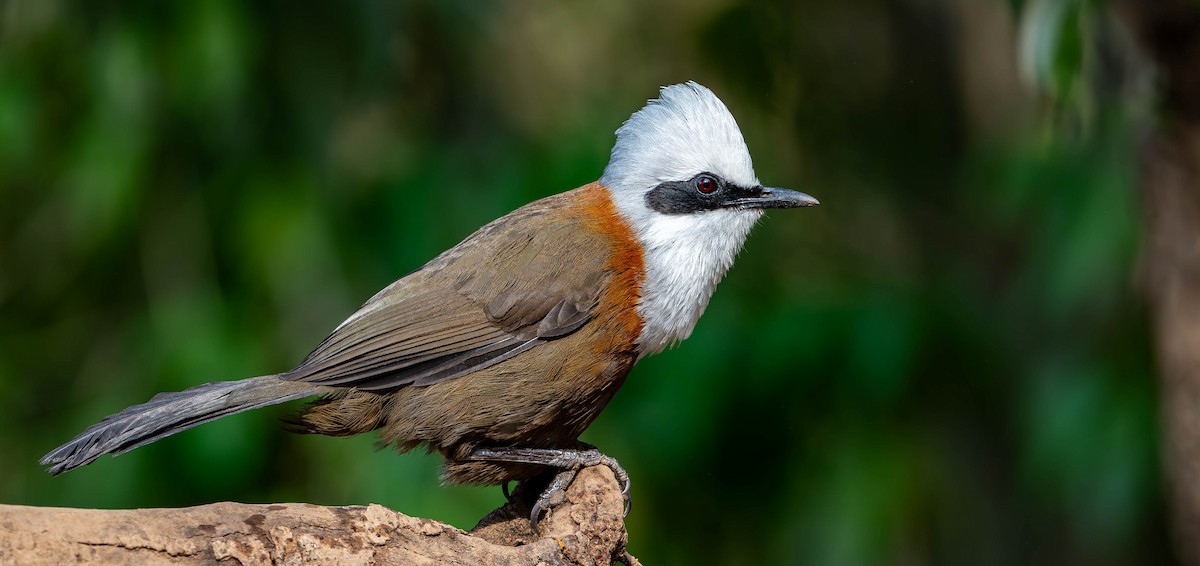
[0,466,637,565]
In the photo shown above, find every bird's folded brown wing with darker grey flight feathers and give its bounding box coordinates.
[283,191,611,391]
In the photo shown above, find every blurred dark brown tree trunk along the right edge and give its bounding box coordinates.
[1117,0,1200,565]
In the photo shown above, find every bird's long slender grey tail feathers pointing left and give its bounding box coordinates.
[41,375,332,475]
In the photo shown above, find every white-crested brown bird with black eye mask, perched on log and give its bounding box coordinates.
[41,82,818,530]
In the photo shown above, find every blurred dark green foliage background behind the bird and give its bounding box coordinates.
[0,0,1174,565]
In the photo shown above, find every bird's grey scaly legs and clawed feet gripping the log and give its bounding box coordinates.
[463,446,630,532]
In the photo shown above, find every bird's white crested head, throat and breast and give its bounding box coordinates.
[600,82,762,356]
